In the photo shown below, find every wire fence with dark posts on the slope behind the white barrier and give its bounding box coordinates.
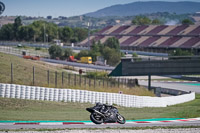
[7,63,138,91]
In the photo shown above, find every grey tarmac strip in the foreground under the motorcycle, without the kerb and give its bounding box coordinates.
[0,121,200,129]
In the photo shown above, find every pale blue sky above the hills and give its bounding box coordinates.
[0,0,200,17]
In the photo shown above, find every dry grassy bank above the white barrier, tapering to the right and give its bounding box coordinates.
[0,53,154,96]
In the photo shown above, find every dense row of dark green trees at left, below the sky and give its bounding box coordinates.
[0,17,88,43]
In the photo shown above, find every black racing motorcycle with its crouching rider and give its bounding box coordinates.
[86,103,126,124]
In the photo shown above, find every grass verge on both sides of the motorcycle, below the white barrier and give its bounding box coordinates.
[0,94,200,121]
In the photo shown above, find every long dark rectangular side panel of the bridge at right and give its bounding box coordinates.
[121,58,200,76]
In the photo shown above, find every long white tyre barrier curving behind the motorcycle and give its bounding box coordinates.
[0,83,195,107]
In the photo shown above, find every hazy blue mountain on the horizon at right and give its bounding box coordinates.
[85,1,200,17]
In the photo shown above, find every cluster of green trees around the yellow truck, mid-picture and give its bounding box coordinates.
[49,37,124,66]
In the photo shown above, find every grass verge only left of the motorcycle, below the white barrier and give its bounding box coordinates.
[0,98,92,120]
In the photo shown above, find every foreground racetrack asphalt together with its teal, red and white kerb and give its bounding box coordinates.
[0,118,200,130]
